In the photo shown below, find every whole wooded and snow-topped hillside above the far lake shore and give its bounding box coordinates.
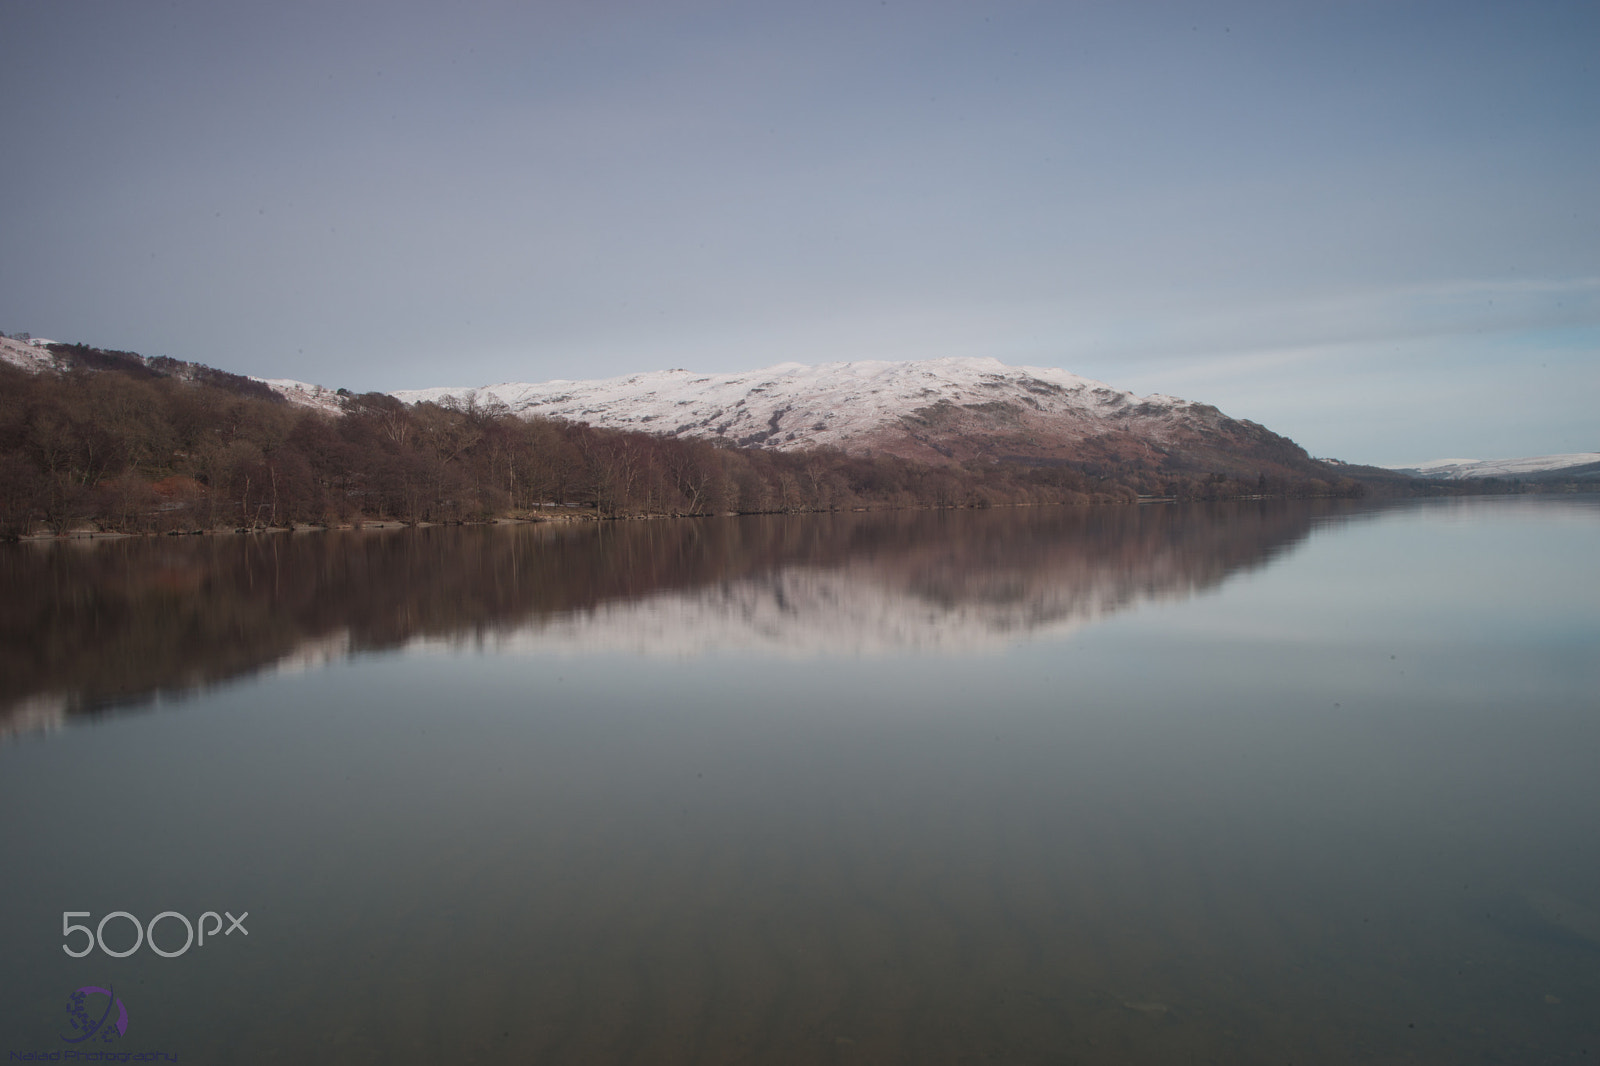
[0,338,1376,538]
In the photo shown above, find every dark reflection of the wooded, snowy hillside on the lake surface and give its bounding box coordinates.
[0,501,1358,736]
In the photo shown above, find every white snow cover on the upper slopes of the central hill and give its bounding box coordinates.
[394,357,1189,448]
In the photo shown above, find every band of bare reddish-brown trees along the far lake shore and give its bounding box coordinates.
[0,344,1371,539]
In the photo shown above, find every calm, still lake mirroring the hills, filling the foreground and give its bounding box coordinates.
[0,496,1600,1064]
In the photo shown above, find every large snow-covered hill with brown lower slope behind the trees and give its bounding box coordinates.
[394,359,1326,477]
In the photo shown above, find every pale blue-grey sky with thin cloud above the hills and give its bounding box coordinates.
[0,0,1600,464]
